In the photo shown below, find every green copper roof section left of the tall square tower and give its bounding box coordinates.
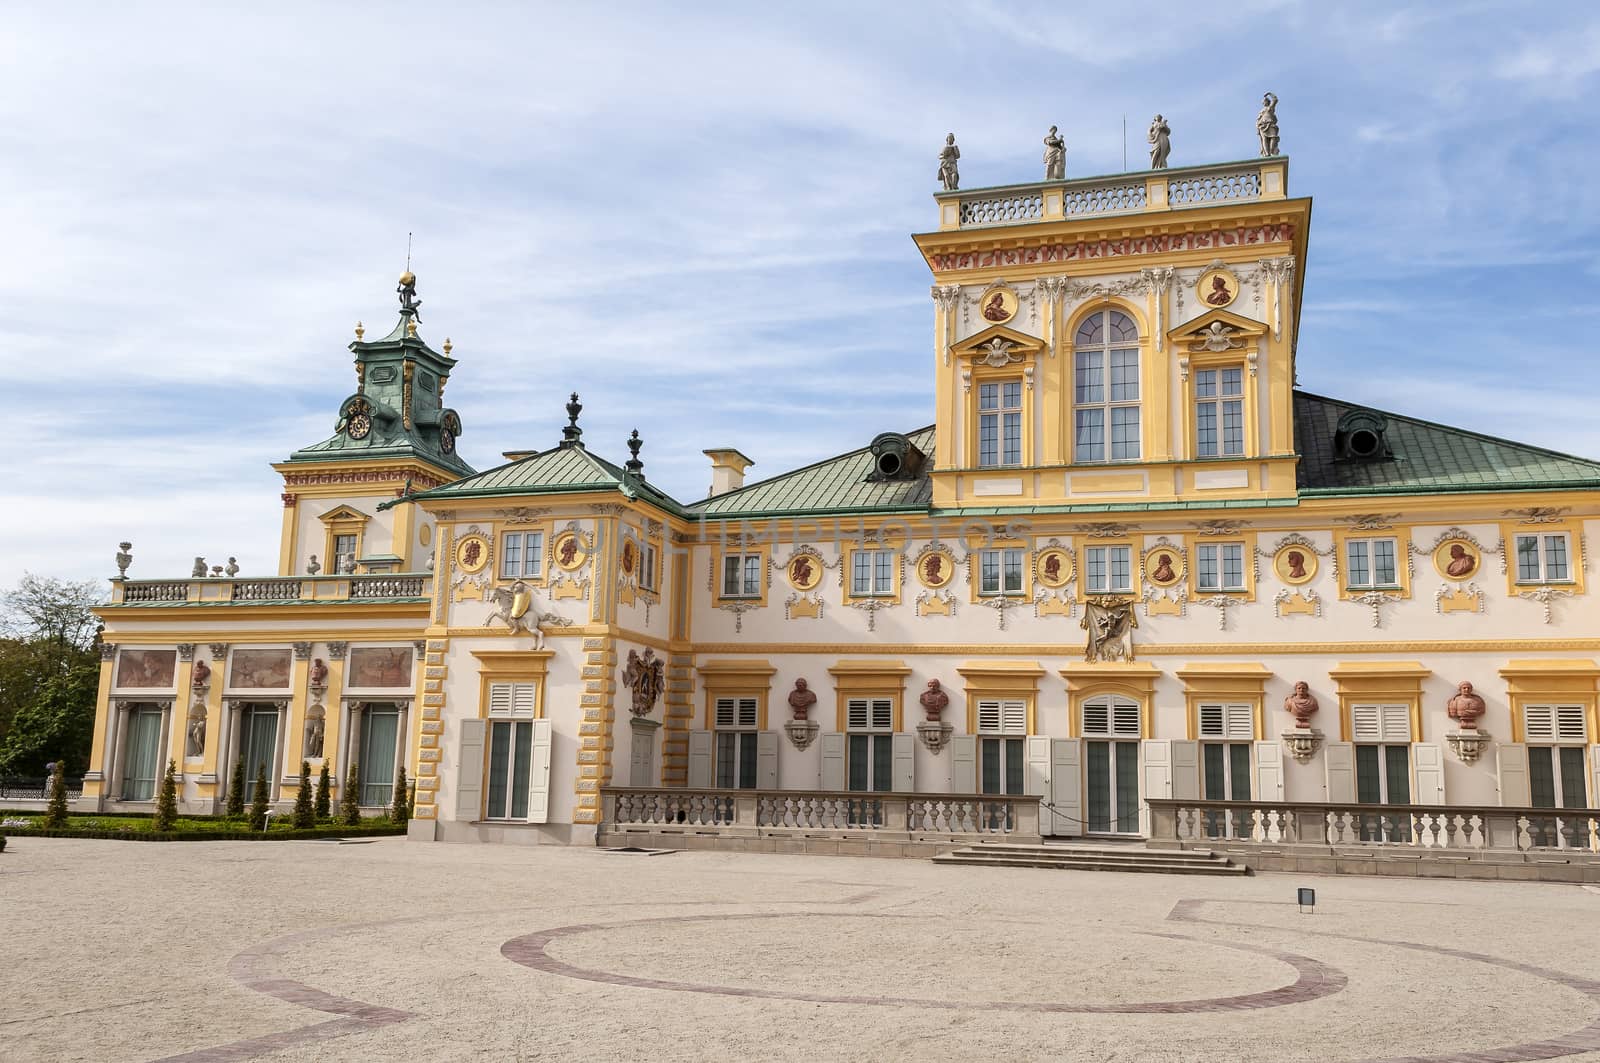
[690,426,933,519]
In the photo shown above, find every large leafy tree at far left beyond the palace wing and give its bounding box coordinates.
[0,573,102,775]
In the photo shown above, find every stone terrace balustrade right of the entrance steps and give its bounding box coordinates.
[1149,797,1600,855]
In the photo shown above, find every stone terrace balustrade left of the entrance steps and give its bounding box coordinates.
[600,786,1038,840]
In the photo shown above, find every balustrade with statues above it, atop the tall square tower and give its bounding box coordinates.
[934,157,1288,229]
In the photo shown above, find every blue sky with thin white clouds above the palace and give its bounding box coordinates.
[0,2,1600,586]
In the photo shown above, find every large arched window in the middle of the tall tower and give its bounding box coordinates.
[1072,311,1139,461]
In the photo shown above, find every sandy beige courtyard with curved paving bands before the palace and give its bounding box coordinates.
[0,839,1600,1063]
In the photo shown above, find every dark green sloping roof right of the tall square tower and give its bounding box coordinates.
[1294,391,1600,495]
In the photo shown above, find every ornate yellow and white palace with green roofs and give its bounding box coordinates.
[85,140,1600,852]
